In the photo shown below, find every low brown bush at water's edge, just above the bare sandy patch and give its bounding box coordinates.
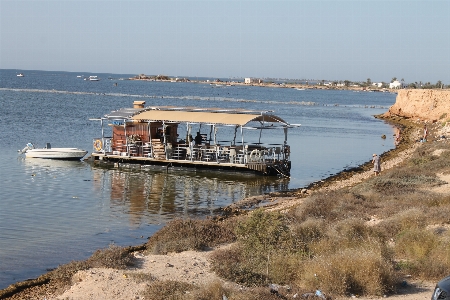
[147,219,236,254]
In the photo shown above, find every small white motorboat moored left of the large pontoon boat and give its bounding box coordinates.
[19,143,87,160]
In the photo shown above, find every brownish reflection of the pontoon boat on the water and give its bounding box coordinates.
[93,166,289,224]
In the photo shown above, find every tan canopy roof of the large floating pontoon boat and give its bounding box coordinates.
[105,106,298,127]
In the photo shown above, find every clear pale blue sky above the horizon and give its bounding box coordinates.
[0,0,450,84]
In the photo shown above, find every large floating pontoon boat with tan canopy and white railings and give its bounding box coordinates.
[91,101,300,177]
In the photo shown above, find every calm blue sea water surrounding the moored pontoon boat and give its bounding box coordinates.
[0,70,395,289]
